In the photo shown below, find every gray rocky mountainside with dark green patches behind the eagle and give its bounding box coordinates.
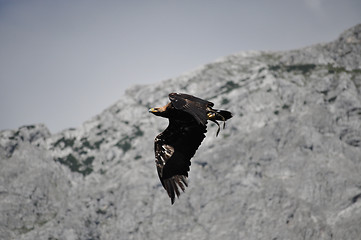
[0,25,361,240]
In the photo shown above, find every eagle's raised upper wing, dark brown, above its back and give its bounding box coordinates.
[169,93,214,125]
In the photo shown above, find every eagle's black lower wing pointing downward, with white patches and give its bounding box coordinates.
[154,119,207,204]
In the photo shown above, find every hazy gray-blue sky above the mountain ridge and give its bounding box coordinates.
[0,0,361,133]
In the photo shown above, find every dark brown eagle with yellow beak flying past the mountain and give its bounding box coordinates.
[149,93,232,204]
